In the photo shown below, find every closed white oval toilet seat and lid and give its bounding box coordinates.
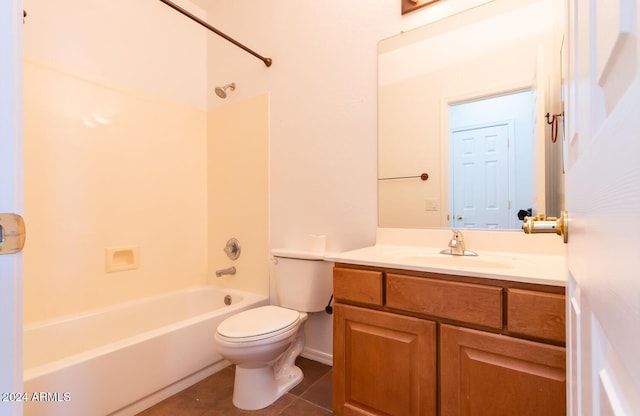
[217,305,300,343]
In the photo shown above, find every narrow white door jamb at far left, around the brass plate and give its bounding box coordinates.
[0,0,22,415]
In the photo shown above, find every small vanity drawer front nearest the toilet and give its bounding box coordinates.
[333,267,382,306]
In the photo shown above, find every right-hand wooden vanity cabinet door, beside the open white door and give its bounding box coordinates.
[440,325,566,416]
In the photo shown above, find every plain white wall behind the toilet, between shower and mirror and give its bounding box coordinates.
[200,0,502,359]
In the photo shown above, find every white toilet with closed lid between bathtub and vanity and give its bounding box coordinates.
[215,249,333,410]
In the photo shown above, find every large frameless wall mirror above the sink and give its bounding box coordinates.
[378,0,564,229]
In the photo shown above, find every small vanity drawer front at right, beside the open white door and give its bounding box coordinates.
[507,289,565,343]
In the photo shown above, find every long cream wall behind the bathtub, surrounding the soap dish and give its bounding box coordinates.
[24,0,207,323]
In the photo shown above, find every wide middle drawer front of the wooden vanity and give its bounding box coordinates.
[387,274,503,329]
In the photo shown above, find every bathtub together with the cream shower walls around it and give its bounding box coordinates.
[23,0,269,415]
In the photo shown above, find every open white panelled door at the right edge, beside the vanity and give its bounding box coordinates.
[565,0,640,416]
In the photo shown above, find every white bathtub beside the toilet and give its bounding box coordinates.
[21,286,268,416]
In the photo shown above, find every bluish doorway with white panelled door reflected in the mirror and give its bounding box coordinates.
[449,90,536,229]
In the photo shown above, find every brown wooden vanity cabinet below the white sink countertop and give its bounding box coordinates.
[333,263,566,416]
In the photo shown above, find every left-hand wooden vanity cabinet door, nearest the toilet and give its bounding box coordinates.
[333,304,437,416]
